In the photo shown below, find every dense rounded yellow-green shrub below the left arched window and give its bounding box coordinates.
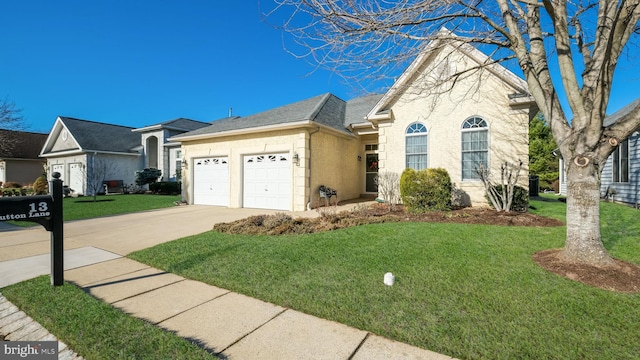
[400,168,452,212]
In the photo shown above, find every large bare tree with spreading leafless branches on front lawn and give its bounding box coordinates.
[263,0,640,266]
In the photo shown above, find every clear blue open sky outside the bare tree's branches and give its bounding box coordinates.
[0,0,640,132]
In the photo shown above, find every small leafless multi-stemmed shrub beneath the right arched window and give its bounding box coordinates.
[476,161,522,212]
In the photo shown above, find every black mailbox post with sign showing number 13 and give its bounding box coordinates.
[0,172,64,286]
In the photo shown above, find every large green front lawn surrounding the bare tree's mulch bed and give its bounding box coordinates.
[130,199,640,359]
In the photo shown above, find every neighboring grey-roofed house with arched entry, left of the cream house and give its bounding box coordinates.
[40,116,209,195]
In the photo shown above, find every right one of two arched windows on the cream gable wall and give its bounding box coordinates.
[462,116,489,180]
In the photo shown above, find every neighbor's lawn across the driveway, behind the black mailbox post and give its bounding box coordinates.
[9,194,180,226]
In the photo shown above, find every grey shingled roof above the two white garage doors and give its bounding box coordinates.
[171,93,358,141]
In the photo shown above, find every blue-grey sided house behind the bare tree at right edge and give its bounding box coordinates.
[560,99,640,205]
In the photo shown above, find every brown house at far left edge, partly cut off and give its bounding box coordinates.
[0,129,47,185]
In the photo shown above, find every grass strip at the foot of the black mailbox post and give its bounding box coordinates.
[2,276,214,360]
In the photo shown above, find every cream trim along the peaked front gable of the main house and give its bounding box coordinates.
[367,28,533,121]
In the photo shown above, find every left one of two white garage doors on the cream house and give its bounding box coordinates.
[193,156,229,206]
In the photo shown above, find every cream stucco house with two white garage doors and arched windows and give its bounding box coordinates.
[170,36,537,211]
